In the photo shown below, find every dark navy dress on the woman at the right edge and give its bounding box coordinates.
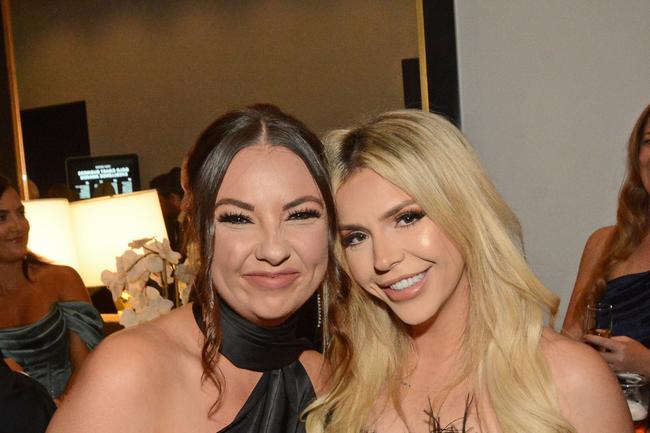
[600,271,650,347]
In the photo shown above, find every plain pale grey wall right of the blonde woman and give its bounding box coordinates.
[456,0,650,324]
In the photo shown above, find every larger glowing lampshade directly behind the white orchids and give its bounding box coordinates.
[70,189,167,287]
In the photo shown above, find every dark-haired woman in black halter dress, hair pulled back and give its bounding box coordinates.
[48,105,336,433]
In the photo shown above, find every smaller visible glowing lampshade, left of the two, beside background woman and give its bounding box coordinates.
[23,198,79,269]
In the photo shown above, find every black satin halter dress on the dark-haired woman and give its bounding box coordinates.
[192,302,316,433]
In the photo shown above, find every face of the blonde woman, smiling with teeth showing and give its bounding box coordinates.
[336,168,468,325]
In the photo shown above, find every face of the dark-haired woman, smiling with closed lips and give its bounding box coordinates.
[211,144,328,326]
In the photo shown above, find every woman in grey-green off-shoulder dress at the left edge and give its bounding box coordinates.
[0,176,103,398]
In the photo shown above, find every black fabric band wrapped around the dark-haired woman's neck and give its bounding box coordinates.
[192,300,314,371]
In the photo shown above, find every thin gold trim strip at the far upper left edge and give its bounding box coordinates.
[0,0,29,200]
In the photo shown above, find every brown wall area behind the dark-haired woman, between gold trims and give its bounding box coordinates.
[12,0,418,185]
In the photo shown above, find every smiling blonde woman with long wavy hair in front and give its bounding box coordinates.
[307,111,632,433]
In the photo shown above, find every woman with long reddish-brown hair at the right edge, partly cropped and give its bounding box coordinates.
[563,105,650,377]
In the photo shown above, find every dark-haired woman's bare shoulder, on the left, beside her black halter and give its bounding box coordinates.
[48,309,200,433]
